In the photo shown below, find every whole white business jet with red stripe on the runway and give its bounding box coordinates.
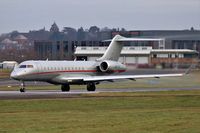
[10,35,183,92]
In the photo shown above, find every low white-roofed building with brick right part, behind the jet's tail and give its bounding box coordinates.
[75,46,198,68]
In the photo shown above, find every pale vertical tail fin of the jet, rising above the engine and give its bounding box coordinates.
[97,35,124,61]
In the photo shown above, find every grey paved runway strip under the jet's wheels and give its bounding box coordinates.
[0,88,200,100]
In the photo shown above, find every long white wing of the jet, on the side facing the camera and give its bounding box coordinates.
[59,73,184,82]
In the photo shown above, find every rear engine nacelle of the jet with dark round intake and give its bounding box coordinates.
[98,60,126,73]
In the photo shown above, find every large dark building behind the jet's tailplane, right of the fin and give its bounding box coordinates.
[112,30,200,55]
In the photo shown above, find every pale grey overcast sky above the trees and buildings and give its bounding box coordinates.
[0,0,200,34]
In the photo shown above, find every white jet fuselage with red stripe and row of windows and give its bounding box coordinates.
[11,61,125,84]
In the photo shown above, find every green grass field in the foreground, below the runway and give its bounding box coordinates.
[0,91,200,133]
